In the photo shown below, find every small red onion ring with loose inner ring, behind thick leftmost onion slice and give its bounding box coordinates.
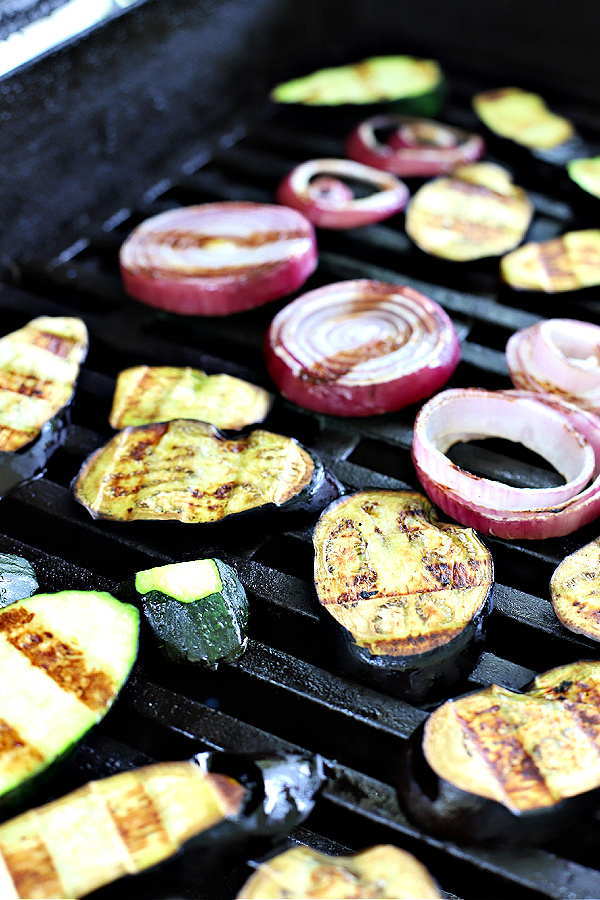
[276,159,409,229]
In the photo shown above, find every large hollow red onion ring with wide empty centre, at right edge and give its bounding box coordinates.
[412,388,600,540]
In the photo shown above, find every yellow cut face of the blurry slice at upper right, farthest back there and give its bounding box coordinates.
[473,87,574,150]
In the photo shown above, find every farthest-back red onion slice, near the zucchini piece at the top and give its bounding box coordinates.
[346,116,485,178]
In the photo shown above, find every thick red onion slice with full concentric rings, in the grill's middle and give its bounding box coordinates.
[265,280,460,416]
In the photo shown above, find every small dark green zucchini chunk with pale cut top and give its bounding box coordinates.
[119,559,248,667]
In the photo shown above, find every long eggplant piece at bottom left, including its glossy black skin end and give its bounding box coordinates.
[0,754,322,900]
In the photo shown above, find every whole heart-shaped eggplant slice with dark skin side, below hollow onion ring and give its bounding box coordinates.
[313,490,493,703]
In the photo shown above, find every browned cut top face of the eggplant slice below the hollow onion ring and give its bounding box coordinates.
[313,491,493,656]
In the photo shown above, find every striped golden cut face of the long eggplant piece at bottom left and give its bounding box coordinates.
[0,762,245,900]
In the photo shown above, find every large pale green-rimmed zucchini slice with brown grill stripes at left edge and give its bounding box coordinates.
[0,591,139,808]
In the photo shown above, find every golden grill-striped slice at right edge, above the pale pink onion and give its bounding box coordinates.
[500,228,600,294]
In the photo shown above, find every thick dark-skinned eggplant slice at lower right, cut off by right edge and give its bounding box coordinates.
[398,661,600,843]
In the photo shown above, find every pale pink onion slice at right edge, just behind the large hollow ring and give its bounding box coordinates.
[506,319,600,413]
